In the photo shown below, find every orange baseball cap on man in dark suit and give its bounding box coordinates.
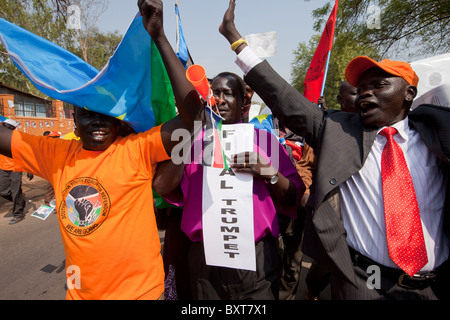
[345,56,419,87]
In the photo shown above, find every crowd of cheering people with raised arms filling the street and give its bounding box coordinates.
[0,0,450,300]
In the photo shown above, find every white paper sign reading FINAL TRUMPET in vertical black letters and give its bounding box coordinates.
[202,124,256,271]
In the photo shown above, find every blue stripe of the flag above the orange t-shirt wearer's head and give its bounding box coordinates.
[0,14,175,132]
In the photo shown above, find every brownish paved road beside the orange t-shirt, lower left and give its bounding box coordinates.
[0,174,329,300]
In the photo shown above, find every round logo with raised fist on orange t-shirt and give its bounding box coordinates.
[58,178,110,236]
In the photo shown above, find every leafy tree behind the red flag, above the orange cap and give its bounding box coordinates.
[291,0,450,109]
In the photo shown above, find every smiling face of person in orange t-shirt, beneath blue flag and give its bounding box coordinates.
[74,108,120,151]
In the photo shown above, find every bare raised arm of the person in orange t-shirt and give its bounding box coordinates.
[138,0,204,154]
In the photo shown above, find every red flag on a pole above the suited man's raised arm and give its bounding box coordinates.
[303,0,338,103]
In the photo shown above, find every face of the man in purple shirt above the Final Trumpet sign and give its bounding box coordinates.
[211,77,243,124]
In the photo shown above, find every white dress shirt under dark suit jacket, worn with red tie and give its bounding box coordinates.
[235,46,450,271]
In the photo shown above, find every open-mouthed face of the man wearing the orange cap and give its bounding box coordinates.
[355,68,417,128]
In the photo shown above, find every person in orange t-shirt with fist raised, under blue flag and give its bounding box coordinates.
[0,0,203,299]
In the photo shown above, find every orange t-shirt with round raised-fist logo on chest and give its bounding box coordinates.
[12,126,169,300]
